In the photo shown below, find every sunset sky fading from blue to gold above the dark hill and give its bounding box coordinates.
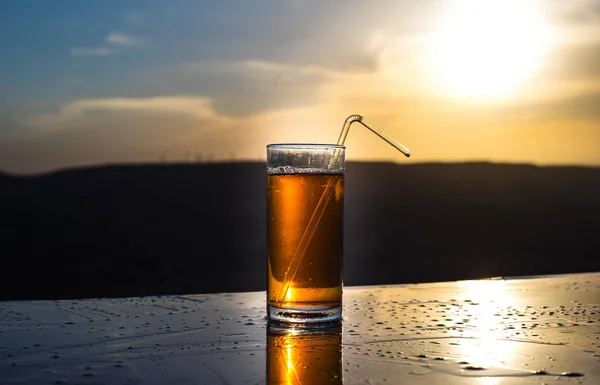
[0,0,600,173]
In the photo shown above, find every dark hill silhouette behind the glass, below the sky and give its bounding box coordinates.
[0,163,600,299]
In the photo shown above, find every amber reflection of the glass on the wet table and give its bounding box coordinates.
[267,323,343,385]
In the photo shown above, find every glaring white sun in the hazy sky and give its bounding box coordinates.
[426,0,551,99]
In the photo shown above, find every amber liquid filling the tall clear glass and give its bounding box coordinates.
[267,174,344,310]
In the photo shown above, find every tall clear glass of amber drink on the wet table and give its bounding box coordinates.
[267,144,345,323]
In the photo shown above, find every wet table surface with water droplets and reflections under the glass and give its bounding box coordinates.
[0,273,600,385]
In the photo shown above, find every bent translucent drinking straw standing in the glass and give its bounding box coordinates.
[276,115,411,307]
